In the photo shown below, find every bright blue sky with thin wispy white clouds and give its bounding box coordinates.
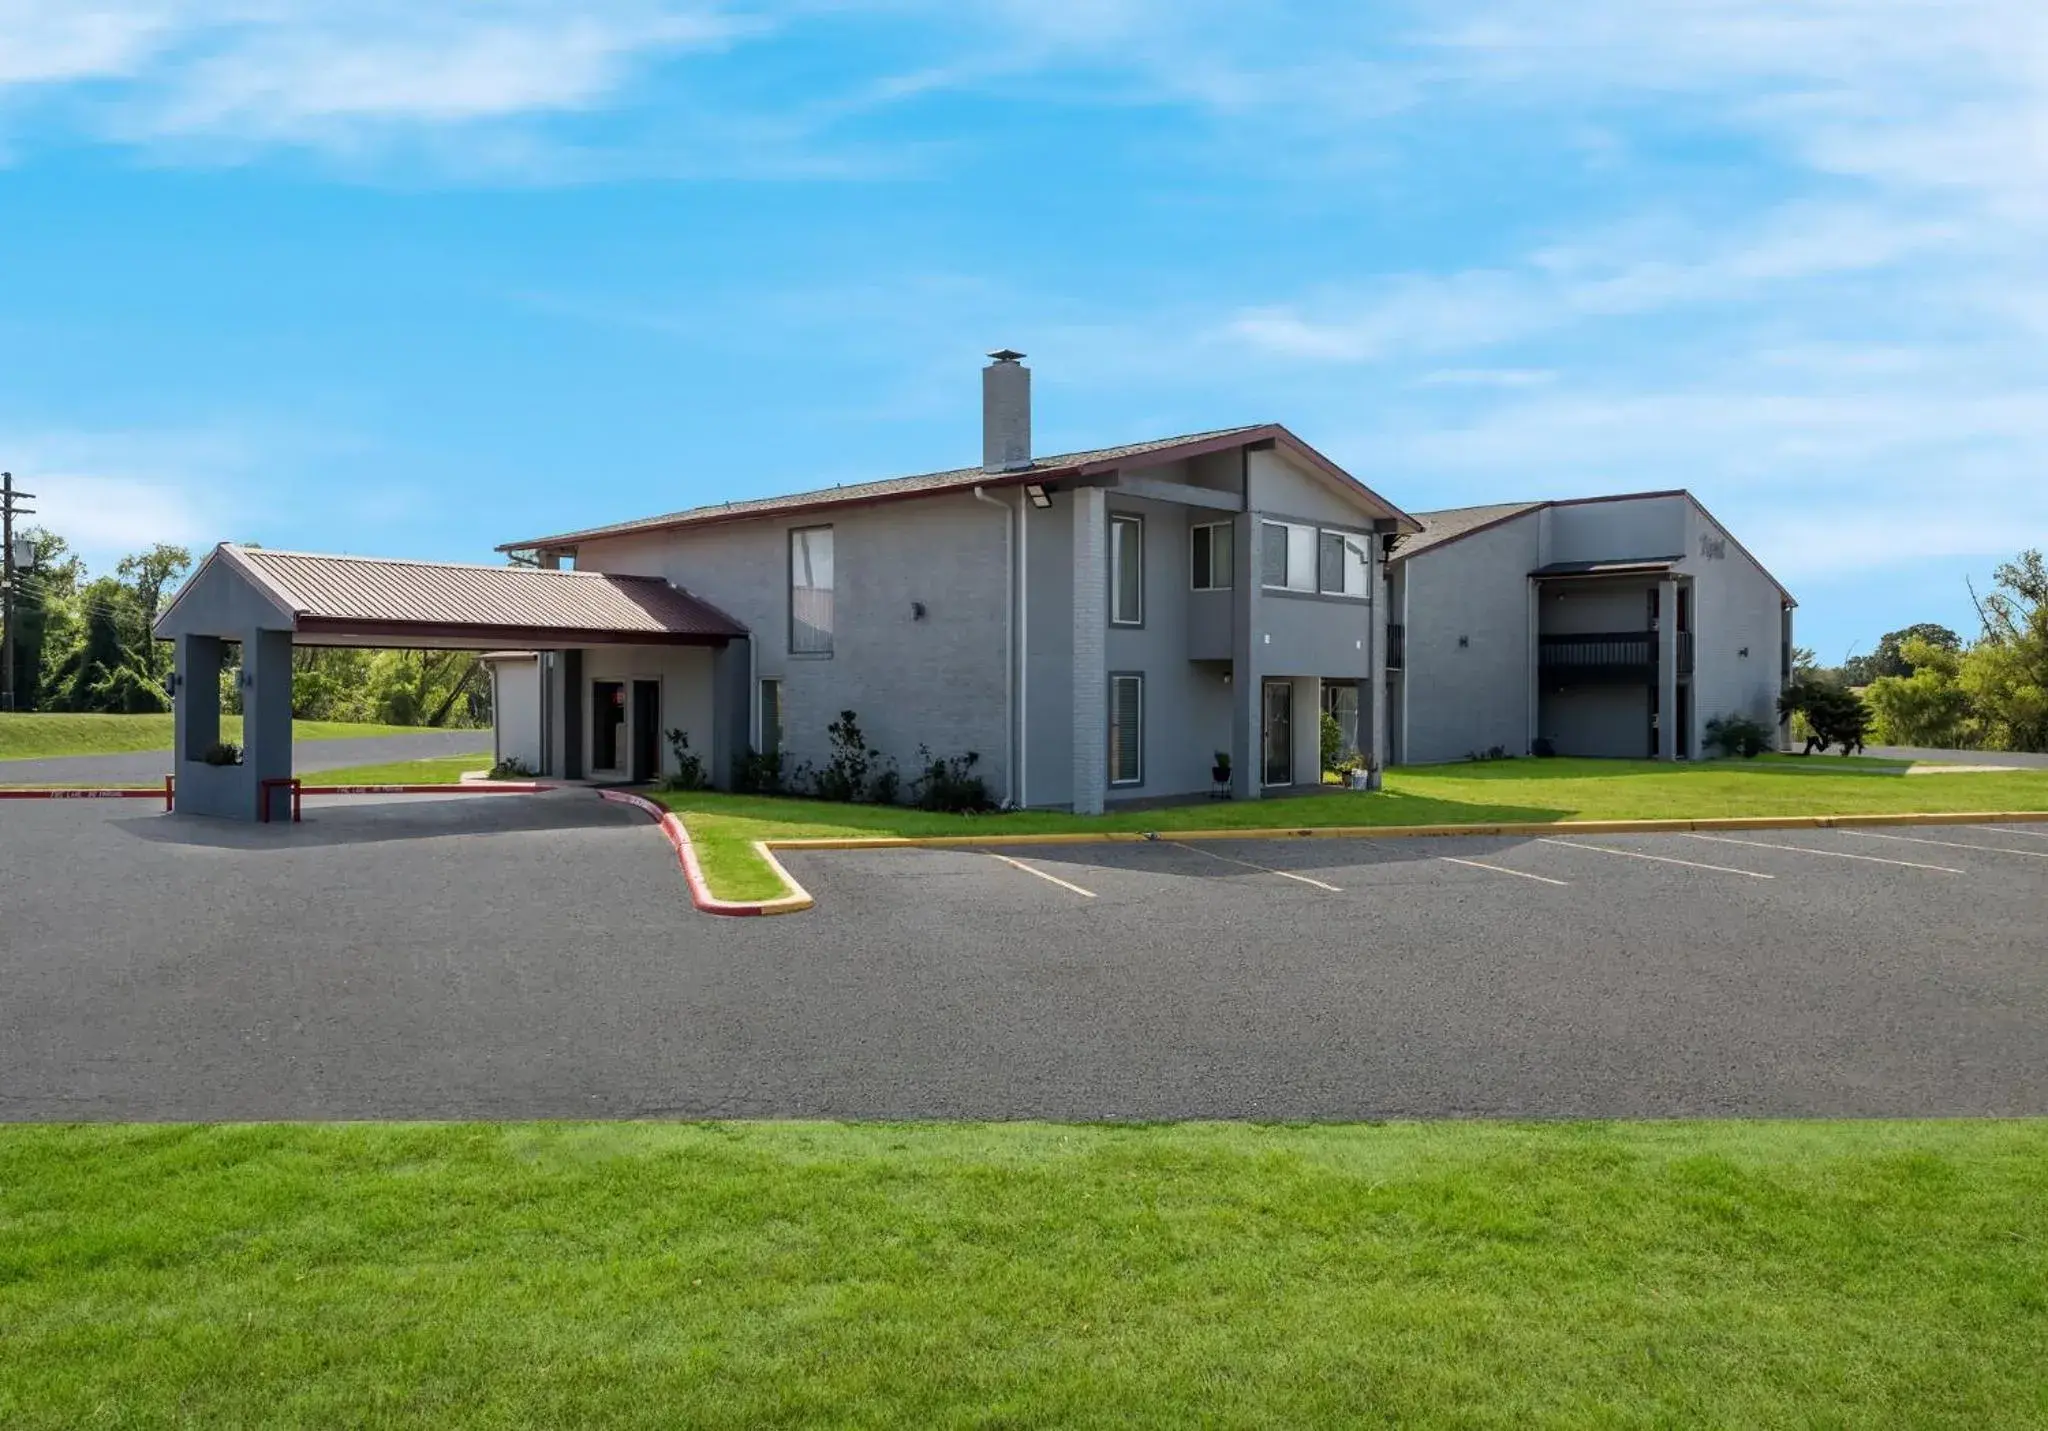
[0,0,2048,661]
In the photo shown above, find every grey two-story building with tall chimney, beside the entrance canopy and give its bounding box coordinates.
[498,352,1419,811]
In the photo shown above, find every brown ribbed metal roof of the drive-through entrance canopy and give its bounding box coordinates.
[215,543,745,645]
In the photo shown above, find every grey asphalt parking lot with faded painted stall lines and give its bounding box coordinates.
[0,792,2048,1120]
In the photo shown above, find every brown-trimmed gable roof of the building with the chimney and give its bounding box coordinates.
[498,422,1413,551]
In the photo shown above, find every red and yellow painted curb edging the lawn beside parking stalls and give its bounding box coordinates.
[630,806,2048,915]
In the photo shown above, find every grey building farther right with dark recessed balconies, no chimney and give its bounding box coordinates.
[1389,491,1794,764]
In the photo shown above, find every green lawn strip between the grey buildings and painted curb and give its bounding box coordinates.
[655,755,2048,899]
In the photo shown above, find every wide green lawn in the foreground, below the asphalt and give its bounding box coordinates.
[0,1122,2048,1431]
